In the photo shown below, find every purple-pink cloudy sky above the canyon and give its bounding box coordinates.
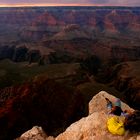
[0,0,140,6]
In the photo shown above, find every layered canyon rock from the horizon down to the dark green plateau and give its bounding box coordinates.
[0,7,140,62]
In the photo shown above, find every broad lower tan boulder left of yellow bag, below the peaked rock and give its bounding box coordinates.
[56,111,126,140]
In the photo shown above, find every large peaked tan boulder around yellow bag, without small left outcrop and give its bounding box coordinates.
[56,91,136,140]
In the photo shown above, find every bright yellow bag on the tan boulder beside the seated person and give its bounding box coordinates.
[107,116,125,135]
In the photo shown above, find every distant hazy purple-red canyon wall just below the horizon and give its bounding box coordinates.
[0,7,140,42]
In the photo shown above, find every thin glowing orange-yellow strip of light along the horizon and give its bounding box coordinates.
[0,3,140,8]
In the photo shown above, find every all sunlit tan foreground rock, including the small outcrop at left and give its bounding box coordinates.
[16,91,140,140]
